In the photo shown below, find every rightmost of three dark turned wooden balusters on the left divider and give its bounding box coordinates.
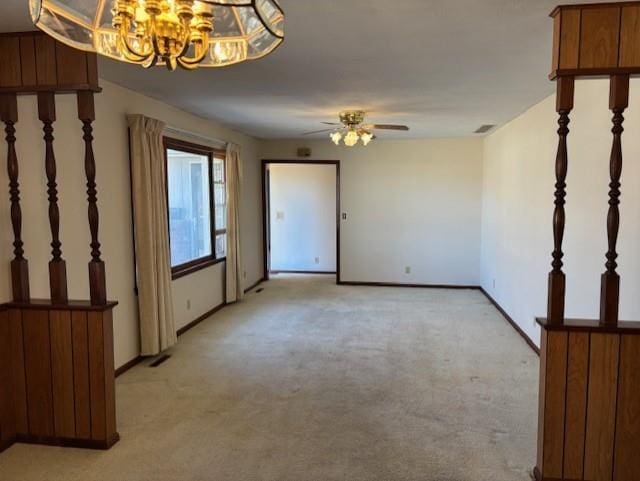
[78,91,107,305]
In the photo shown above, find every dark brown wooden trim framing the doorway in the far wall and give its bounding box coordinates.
[261,159,340,284]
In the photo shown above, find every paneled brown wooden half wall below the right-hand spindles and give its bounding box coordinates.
[536,319,640,481]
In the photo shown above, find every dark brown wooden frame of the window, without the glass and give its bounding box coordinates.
[162,136,227,280]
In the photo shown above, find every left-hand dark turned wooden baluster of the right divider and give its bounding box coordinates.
[547,77,575,324]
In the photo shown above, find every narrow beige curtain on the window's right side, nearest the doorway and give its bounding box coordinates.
[226,143,244,303]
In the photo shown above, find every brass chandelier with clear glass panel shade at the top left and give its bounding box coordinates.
[29,0,284,70]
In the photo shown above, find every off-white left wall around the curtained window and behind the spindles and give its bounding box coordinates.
[0,81,263,366]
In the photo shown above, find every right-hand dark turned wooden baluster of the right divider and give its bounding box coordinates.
[600,75,629,325]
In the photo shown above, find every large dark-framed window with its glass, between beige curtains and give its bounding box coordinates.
[164,138,227,279]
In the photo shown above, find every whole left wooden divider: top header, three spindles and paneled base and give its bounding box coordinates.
[0,32,119,451]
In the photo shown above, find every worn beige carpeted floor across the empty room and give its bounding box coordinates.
[0,275,538,481]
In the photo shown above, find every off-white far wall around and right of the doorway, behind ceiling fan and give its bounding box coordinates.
[262,138,482,285]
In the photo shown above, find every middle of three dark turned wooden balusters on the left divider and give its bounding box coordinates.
[38,92,68,304]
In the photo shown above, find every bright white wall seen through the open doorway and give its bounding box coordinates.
[269,164,336,272]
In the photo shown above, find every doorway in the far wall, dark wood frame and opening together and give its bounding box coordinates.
[262,160,340,283]
